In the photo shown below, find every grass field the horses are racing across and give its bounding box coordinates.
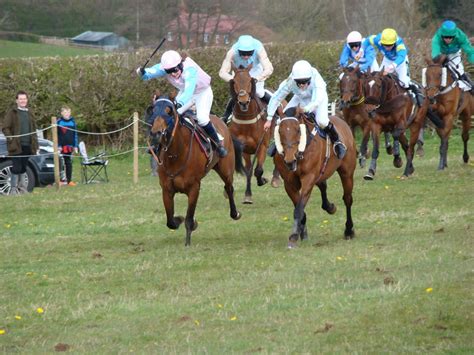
[0,132,474,354]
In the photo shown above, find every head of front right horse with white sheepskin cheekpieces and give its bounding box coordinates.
[274,107,306,171]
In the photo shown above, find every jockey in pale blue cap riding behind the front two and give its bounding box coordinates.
[219,35,273,122]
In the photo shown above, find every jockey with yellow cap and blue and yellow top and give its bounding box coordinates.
[368,28,423,106]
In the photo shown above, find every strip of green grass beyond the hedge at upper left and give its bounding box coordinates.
[0,40,106,58]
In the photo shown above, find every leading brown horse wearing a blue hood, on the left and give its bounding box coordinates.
[151,93,243,246]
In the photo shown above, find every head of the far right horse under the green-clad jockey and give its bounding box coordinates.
[421,55,450,104]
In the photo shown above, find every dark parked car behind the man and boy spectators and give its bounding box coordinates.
[0,132,65,195]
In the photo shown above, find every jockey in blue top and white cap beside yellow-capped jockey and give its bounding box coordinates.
[339,31,380,73]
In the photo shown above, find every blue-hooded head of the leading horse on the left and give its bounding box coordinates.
[150,96,178,143]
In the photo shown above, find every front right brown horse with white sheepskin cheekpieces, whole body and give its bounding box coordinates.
[273,108,357,248]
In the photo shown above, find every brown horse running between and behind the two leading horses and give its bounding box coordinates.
[229,64,280,204]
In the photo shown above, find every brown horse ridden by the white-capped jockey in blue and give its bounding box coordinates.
[339,65,392,168]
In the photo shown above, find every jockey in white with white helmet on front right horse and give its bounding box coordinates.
[264,60,346,159]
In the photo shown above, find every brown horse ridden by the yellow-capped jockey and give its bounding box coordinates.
[364,68,428,180]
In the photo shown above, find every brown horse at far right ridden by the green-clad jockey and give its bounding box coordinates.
[423,55,474,170]
